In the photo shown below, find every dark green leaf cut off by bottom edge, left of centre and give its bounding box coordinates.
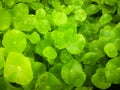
[35,72,62,90]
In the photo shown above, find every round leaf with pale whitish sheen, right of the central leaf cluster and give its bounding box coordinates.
[66,34,86,54]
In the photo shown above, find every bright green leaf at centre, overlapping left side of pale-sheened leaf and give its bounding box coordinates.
[51,27,74,49]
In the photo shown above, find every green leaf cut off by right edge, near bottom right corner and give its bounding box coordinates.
[105,57,120,84]
